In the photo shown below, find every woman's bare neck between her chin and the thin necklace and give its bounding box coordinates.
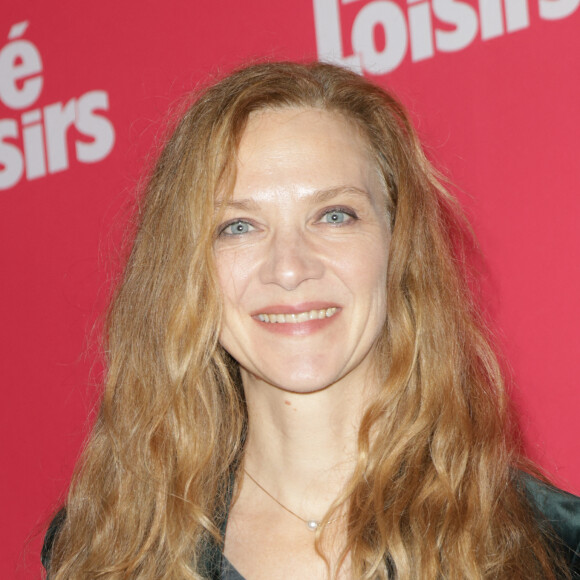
[242,371,368,518]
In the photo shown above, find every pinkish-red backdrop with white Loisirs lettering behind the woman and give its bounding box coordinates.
[0,0,580,578]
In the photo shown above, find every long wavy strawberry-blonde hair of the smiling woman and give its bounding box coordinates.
[50,62,558,580]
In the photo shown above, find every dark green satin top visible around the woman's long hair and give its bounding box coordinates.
[41,474,580,580]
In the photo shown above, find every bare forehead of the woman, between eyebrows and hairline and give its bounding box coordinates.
[233,108,382,205]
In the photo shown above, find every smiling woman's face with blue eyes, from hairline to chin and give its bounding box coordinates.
[215,108,390,392]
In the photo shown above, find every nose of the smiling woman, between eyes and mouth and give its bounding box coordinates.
[260,232,324,290]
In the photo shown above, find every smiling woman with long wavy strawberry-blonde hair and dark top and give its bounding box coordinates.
[45,63,580,580]
